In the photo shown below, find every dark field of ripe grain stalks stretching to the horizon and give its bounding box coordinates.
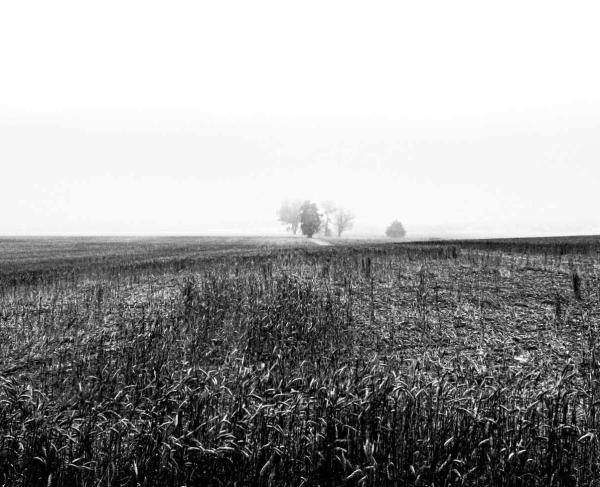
[0,236,600,486]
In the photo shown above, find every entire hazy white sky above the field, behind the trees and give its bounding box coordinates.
[0,0,600,235]
